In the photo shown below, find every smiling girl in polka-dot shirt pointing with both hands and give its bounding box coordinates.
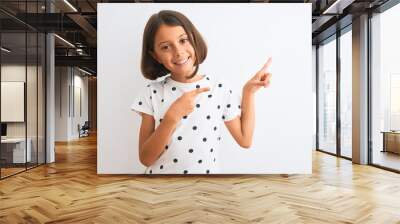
[132,10,271,174]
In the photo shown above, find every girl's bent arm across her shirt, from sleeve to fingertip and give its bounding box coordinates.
[139,87,209,166]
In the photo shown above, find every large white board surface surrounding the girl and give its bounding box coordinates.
[97,3,313,174]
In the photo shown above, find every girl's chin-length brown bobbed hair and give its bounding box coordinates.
[141,10,207,80]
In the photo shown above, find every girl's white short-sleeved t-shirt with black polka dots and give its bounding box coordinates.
[131,75,241,174]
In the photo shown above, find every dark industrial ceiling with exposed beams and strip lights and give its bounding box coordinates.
[0,0,394,73]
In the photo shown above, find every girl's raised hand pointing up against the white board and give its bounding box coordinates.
[243,58,272,93]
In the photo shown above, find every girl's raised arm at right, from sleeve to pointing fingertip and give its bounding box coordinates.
[225,58,272,148]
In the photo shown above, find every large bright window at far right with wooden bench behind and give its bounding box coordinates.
[370,4,400,171]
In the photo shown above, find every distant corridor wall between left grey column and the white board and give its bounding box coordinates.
[55,67,88,141]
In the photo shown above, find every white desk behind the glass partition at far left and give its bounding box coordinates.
[1,138,32,163]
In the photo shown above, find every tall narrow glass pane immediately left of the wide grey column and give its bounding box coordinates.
[339,26,353,158]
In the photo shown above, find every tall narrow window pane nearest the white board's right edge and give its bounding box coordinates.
[317,37,336,154]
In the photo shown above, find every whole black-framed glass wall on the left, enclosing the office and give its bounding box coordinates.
[0,1,46,178]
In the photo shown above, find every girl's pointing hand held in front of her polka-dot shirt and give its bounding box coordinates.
[164,87,210,123]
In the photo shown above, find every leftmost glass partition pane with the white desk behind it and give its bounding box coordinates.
[0,32,27,178]
